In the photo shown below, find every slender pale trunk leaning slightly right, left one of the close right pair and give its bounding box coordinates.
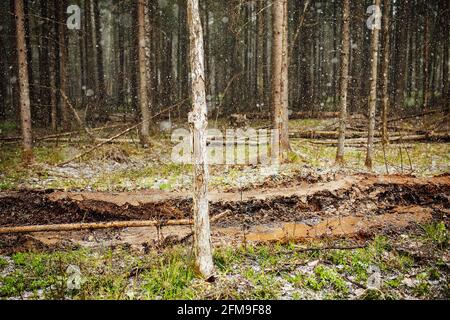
[366,0,381,170]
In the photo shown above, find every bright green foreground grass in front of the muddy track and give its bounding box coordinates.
[0,232,445,299]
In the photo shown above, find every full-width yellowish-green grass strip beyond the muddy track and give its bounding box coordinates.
[0,119,450,191]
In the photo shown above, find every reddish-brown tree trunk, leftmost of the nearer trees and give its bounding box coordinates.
[14,0,33,163]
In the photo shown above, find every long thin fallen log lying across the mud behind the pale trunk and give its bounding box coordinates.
[0,210,230,234]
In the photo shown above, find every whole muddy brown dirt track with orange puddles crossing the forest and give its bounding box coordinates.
[0,175,450,252]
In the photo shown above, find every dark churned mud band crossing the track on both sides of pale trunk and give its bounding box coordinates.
[0,180,450,227]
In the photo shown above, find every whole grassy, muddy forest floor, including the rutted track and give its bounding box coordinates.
[0,118,450,299]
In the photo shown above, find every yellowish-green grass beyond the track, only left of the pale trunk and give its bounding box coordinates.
[0,144,192,191]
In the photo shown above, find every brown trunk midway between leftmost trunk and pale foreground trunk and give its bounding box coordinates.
[137,0,150,147]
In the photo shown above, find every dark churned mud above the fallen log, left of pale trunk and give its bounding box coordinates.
[0,191,190,226]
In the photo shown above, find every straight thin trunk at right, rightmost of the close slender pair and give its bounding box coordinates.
[382,0,391,145]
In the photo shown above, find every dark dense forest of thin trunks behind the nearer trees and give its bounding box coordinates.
[0,0,449,130]
